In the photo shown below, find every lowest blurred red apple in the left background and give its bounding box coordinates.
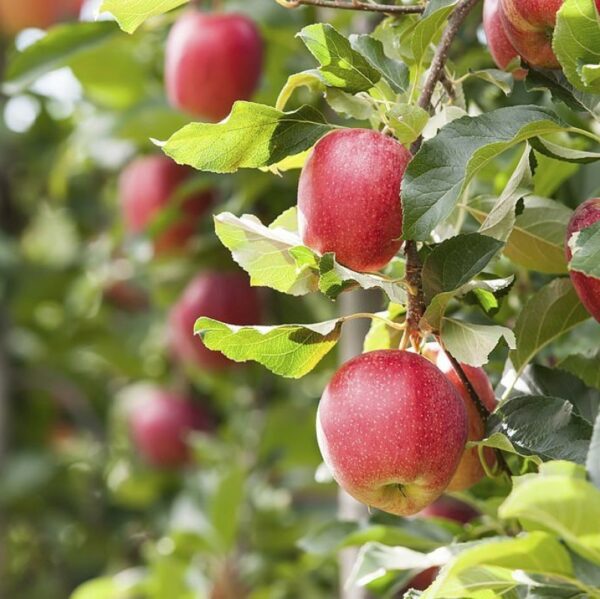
[129,389,212,468]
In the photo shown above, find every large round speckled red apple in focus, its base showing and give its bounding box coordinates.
[317,350,467,516]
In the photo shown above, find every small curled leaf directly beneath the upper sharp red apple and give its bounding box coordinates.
[319,253,407,305]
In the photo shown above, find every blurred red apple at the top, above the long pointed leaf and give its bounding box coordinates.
[165,11,263,121]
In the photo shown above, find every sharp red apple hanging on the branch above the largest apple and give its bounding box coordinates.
[298,129,412,272]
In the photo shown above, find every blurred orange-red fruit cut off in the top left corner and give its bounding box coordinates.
[0,0,84,35]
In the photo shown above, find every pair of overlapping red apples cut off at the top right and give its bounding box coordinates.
[483,0,600,74]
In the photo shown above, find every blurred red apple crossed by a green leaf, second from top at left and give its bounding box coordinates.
[119,155,214,254]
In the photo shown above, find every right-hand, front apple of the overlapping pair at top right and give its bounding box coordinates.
[500,0,563,69]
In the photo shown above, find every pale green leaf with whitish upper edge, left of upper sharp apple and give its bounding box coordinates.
[215,208,319,295]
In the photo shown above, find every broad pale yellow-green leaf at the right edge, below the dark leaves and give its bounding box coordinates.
[499,463,600,564]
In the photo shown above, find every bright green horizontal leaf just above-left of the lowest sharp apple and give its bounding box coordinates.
[194,318,342,378]
